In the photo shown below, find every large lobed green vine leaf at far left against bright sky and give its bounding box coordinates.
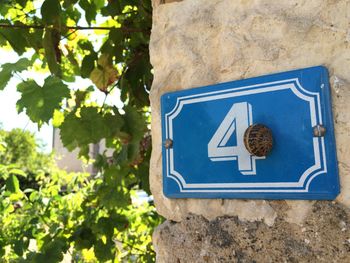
[17,76,70,127]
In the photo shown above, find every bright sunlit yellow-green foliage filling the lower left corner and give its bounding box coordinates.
[0,130,161,262]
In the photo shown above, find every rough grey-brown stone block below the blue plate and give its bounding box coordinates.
[153,201,350,263]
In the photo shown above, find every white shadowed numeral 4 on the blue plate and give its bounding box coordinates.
[208,102,265,175]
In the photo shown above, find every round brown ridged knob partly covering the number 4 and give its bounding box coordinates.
[243,124,273,157]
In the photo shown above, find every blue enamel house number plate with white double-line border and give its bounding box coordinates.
[161,66,339,199]
